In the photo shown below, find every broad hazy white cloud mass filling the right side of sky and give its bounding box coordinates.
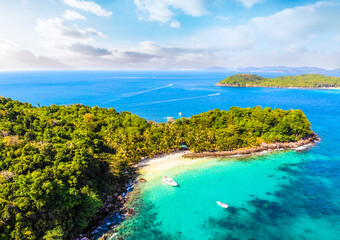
[174,1,340,68]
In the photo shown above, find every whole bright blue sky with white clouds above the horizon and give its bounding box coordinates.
[0,0,340,70]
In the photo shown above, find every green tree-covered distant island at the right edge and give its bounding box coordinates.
[219,74,340,88]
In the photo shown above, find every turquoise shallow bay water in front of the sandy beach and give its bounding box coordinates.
[120,152,340,239]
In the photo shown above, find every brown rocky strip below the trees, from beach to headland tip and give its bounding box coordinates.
[183,134,320,158]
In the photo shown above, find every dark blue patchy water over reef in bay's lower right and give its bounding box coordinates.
[203,155,340,240]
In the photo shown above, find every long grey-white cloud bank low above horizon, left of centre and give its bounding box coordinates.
[64,41,209,69]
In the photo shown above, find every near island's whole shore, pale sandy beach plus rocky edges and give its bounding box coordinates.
[87,134,320,239]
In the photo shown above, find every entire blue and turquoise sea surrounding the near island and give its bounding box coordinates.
[0,70,340,240]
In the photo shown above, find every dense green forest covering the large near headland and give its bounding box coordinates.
[0,98,311,240]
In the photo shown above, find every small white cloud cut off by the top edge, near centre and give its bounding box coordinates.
[134,0,206,27]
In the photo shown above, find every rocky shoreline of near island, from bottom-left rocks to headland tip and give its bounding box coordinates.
[81,134,320,240]
